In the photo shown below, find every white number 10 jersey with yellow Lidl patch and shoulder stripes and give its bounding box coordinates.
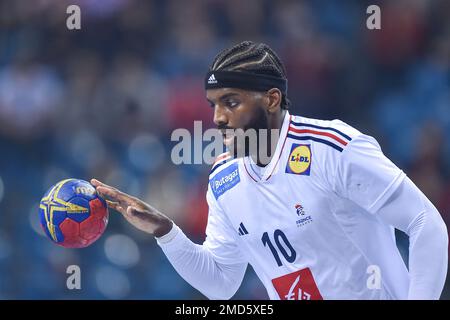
[204,112,409,299]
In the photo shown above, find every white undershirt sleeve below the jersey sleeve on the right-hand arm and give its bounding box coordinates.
[377,177,448,300]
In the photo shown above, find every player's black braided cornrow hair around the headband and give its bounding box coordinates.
[209,41,291,110]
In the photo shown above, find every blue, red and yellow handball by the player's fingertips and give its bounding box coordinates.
[39,179,108,248]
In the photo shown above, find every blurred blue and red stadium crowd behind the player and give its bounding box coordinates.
[0,0,450,299]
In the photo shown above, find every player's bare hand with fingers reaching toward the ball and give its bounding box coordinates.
[91,179,173,237]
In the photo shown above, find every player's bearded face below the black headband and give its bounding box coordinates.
[206,88,269,157]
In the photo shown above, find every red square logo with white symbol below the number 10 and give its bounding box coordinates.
[272,268,323,300]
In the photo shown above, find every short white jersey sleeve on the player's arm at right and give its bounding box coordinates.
[334,134,405,214]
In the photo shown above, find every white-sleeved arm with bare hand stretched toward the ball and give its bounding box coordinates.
[91,179,247,299]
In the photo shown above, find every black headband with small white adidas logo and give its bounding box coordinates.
[205,71,287,95]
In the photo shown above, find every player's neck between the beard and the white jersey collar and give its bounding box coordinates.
[250,110,286,167]
